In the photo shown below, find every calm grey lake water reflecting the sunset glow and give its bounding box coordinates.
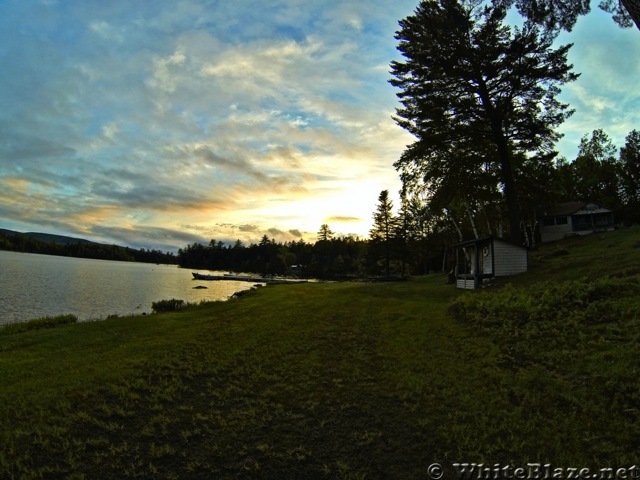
[0,250,253,324]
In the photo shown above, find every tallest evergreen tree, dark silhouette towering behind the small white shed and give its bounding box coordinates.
[391,0,577,246]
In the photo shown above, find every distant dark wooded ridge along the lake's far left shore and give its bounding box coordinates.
[0,232,177,264]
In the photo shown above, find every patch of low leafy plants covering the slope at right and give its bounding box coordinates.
[449,279,640,390]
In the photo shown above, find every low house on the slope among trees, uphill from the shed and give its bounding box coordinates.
[540,202,614,242]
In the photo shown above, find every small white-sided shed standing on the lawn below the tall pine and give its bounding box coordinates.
[454,236,529,290]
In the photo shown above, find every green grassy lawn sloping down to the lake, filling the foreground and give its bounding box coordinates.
[0,229,640,480]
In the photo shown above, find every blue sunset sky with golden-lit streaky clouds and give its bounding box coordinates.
[0,0,640,251]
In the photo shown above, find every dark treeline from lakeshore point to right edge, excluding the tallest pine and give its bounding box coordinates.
[178,129,640,278]
